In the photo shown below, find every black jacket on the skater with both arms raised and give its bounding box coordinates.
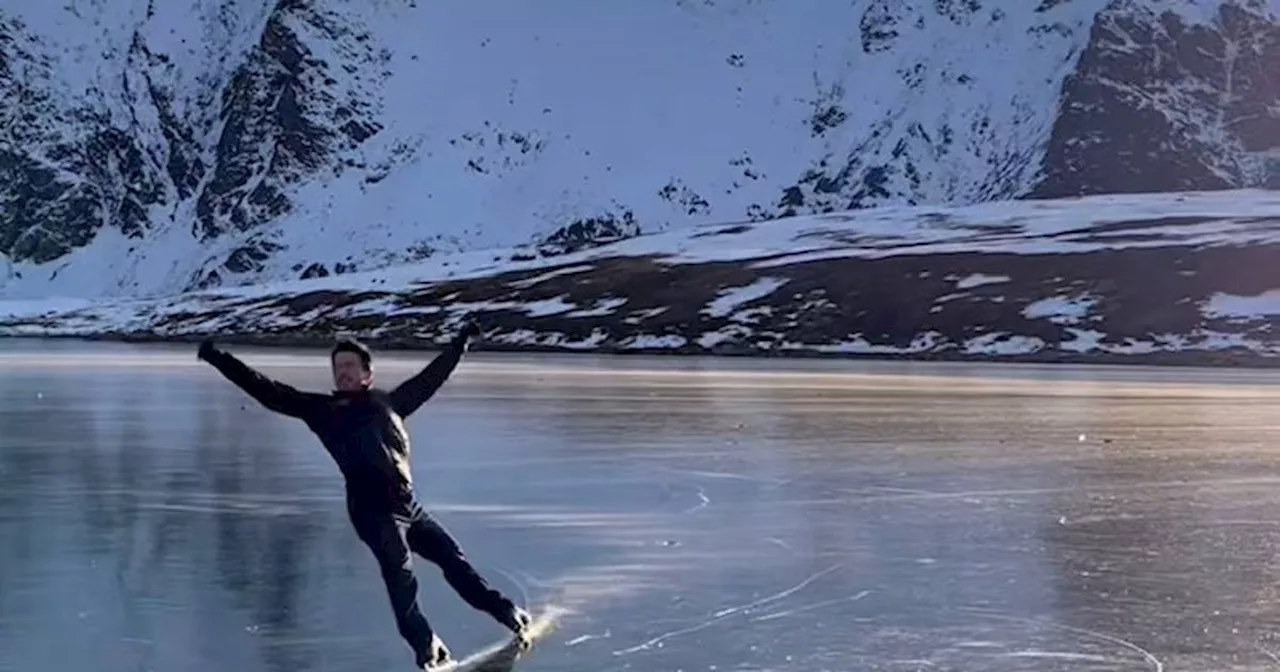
[200,342,466,516]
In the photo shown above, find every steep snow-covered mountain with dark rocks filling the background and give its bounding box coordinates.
[0,0,1280,298]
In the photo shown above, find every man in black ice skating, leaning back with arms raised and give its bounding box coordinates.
[198,324,529,669]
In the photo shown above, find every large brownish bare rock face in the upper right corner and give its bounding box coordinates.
[1030,0,1280,198]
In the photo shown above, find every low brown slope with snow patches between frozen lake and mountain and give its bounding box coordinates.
[0,191,1280,364]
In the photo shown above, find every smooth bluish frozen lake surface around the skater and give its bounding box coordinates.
[0,340,1280,672]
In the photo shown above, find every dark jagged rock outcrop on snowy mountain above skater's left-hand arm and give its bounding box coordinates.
[196,0,389,285]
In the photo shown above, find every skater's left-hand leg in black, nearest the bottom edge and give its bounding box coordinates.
[355,516,440,668]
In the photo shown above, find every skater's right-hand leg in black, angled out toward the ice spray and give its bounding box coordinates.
[404,511,527,632]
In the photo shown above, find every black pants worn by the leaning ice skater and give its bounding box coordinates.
[351,504,515,667]
